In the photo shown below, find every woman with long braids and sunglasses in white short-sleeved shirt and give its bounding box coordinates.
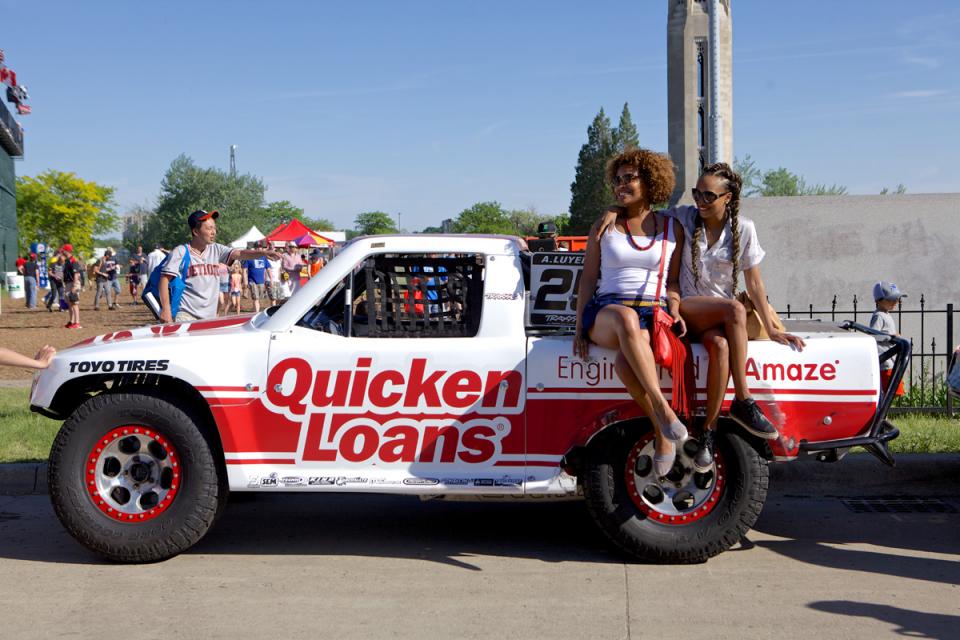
[600,162,804,471]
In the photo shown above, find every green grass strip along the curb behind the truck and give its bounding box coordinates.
[0,388,960,463]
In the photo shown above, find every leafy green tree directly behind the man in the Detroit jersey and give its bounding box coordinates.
[144,154,269,247]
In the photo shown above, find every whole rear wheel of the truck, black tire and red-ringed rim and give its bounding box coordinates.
[584,428,769,564]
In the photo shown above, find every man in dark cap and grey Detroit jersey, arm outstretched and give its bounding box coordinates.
[159,209,280,322]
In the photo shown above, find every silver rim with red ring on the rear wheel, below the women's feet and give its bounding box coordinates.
[624,433,726,526]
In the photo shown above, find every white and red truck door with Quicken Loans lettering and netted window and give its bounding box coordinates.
[266,254,524,493]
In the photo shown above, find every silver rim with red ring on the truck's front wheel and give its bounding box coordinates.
[84,425,181,522]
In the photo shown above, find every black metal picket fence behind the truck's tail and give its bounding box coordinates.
[778,295,955,416]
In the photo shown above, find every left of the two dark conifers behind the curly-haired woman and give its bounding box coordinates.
[568,108,614,235]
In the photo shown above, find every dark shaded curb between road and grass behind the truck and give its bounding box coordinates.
[0,453,960,496]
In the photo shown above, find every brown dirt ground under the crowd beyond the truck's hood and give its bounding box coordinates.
[0,288,260,380]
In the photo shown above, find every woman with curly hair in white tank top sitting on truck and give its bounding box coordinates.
[573,149,687,477]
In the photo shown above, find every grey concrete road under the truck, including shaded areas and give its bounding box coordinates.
[0,463,960,640]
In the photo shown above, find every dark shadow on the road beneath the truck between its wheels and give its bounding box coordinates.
[190,494,624,570]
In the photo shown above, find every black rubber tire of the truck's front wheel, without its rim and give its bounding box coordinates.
[48,392,228,563]
